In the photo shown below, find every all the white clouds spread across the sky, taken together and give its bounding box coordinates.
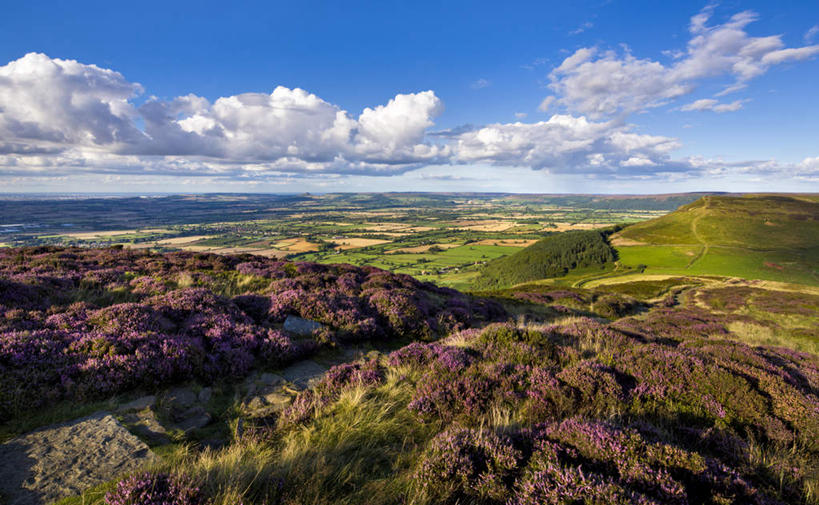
[0,7,819,187]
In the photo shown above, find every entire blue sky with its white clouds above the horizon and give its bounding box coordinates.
[0,1,819,193]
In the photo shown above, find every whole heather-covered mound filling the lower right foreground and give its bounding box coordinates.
[388,316,819,505]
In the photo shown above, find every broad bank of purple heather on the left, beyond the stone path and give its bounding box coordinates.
[0,247,504,421]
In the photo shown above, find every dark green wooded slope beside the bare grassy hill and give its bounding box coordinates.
[473,230,615,290]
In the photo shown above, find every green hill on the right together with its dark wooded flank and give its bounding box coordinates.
[475,195,819,289]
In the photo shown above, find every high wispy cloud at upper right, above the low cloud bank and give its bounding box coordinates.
[550,7,819,118]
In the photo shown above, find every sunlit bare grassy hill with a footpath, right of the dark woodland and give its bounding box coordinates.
[611,195,819,284]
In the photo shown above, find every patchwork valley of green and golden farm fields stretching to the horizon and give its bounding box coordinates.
[0,193,700,288]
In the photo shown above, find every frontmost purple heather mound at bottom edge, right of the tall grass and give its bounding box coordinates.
[416,418,775,505]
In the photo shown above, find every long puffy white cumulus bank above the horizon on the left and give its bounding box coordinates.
[0,53,449,174]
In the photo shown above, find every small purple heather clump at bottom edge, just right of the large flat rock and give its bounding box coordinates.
[105,473,207,505]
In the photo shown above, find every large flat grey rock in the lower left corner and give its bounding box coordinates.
[0,412,157,505]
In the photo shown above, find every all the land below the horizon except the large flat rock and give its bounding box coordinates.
[0,194,819,505]
